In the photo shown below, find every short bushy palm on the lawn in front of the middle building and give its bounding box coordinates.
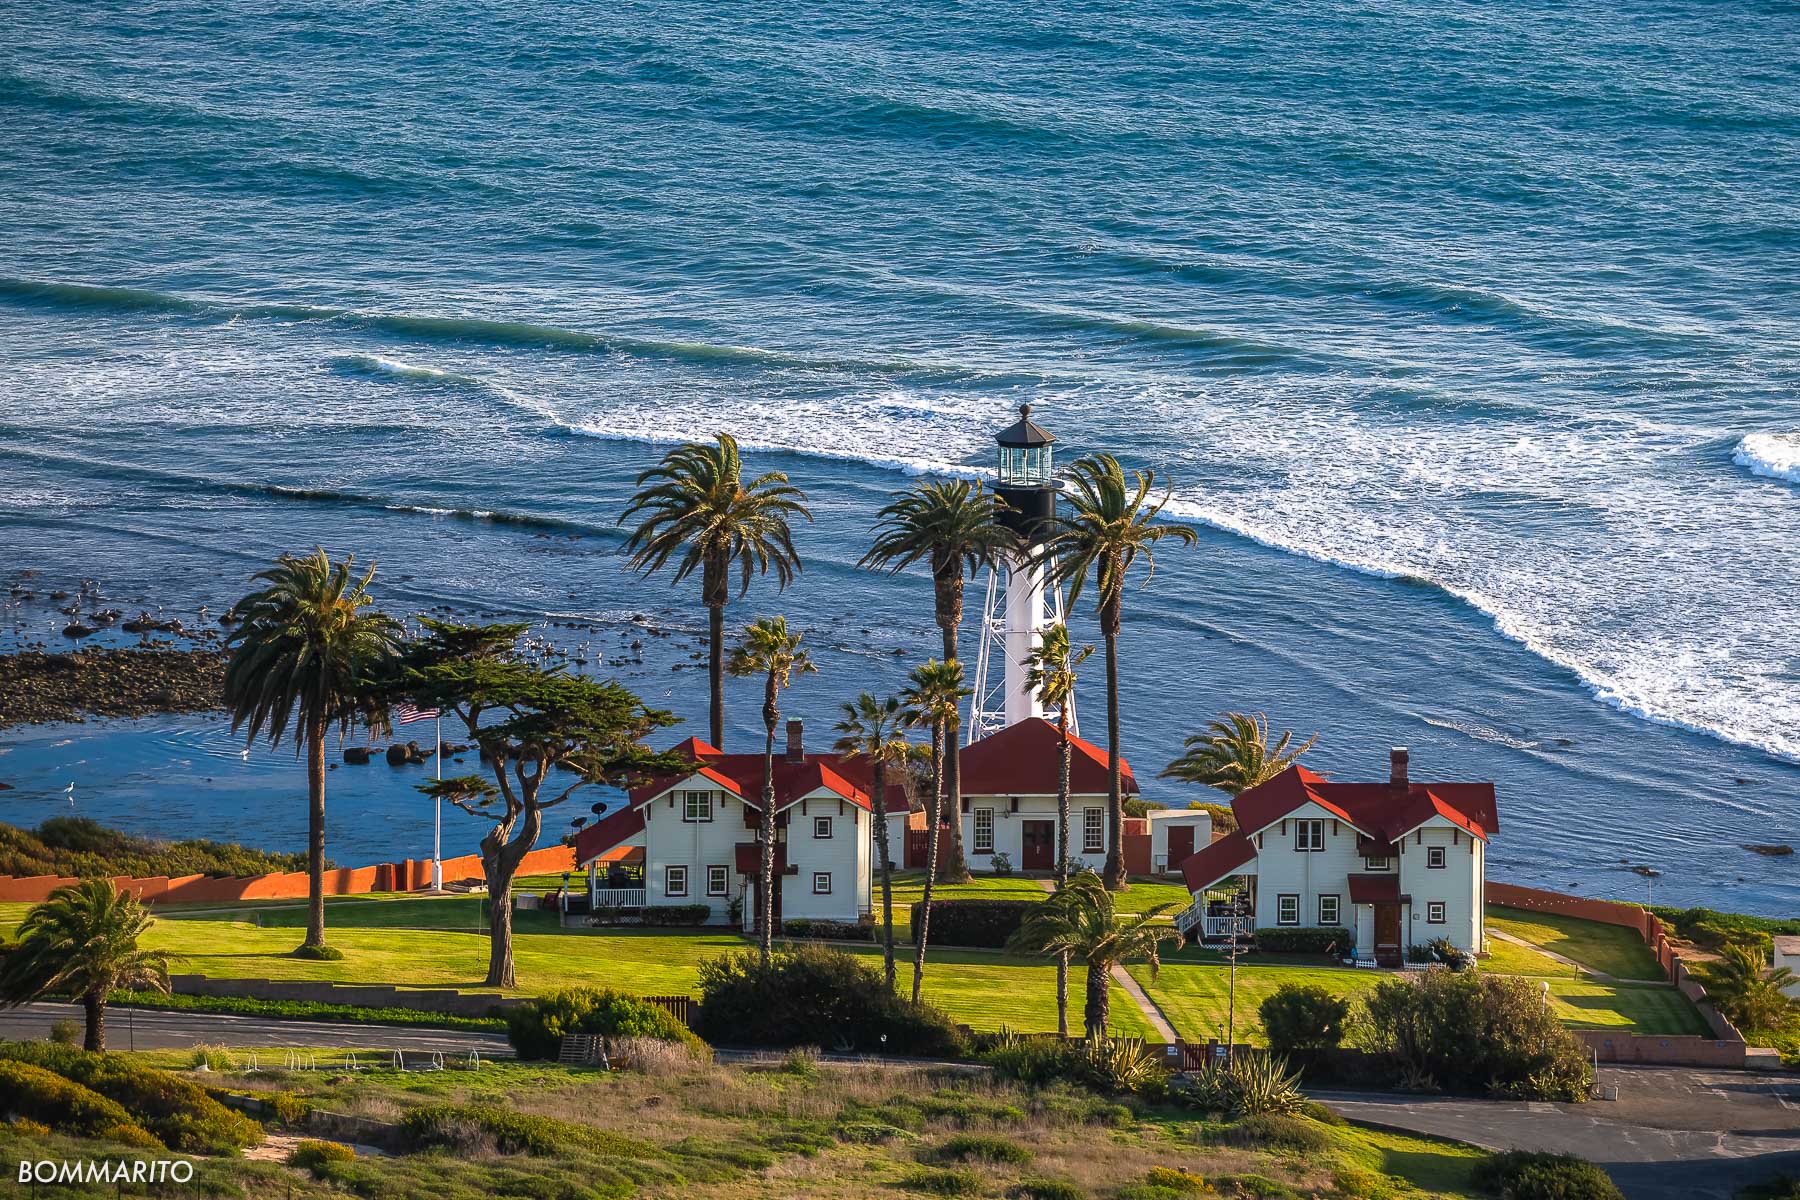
[1006,871,1175,1038]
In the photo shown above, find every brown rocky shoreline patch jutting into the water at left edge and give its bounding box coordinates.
[0,648,225,729]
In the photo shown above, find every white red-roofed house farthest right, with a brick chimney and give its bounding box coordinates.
[1177,747,1499,966]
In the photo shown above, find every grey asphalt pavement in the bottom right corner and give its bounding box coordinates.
[1312,1067,1800,1200]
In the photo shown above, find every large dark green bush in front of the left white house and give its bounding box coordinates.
[697,946,967,1058]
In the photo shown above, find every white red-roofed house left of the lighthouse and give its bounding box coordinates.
[576,721,874,928]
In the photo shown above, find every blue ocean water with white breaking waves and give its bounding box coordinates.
[0,0,1800,912]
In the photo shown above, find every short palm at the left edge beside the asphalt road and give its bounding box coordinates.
[0,880,169,1051]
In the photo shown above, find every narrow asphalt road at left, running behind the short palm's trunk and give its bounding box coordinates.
[0,1004,513,1058]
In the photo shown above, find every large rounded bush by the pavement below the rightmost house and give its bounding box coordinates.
[1363,966,1593,1101]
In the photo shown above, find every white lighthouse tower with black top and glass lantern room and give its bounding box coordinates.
[963,405,1076,741]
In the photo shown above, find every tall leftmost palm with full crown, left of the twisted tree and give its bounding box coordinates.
[225,549,400,957]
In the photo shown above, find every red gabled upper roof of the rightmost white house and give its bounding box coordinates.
[1231,765,1499,842]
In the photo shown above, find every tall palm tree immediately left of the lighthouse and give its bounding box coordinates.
[860,480,1019,883]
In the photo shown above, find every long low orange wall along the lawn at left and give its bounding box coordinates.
[0,846,574,905]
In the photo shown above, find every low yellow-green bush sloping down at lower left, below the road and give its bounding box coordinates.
[0,1042,263,1155]
